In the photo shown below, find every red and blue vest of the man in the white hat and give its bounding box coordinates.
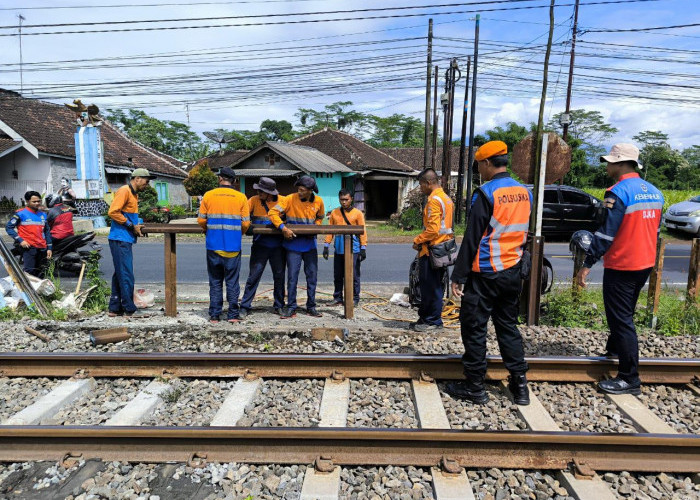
[603,173,664,271]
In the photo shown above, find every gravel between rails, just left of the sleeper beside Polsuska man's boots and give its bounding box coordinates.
[348,378,418,429]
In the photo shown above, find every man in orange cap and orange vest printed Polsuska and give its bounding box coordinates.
[446,141,532,405]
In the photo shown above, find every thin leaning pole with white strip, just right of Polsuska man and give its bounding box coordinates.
[527,0,555,325]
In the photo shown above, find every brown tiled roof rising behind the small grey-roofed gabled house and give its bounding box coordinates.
[290,128,413,173]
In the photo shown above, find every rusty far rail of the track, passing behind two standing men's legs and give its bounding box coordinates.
[0,352,700,384]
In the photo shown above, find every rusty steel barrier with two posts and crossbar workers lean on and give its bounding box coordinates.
[142,224,365,319]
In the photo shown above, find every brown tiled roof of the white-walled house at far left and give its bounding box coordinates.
[0,92,187,178]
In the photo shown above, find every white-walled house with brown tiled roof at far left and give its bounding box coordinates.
[0,89,189,215]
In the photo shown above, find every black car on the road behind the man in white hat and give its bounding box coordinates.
[527,184,603,238]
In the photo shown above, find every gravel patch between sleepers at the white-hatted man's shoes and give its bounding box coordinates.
[530,382,640,433]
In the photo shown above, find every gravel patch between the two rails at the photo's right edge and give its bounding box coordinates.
[637,385,700,434]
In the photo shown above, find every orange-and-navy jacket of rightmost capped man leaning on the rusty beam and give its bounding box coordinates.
[268,193,326,252]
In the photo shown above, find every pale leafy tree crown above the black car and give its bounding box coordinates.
[546,109,617,165]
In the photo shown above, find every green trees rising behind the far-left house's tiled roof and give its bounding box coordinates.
[106,109,209,161]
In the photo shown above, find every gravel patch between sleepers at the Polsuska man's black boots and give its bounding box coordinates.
[438,383,527,431]
